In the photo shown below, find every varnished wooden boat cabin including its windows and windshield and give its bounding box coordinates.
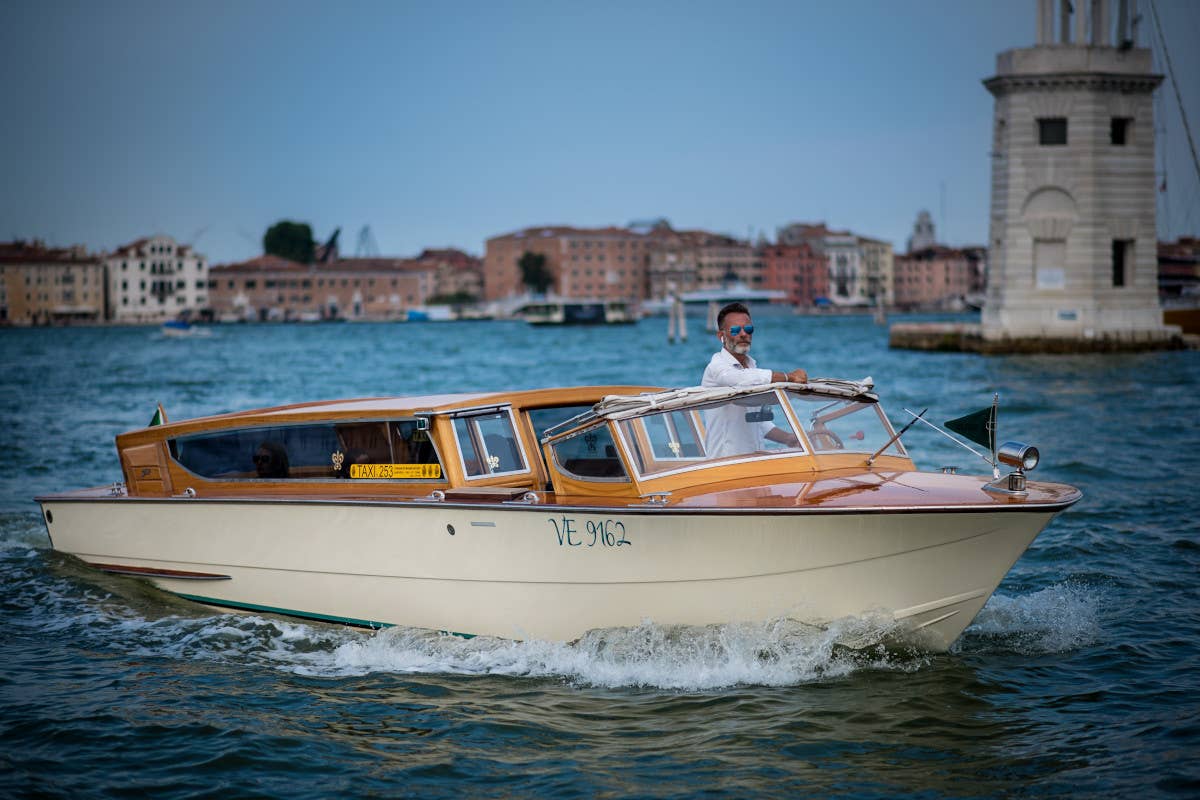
[116,381,913,503]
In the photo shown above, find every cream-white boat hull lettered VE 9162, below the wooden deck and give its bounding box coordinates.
[41,498,1057,650]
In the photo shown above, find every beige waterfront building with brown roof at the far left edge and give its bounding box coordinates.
[0,240,106,325]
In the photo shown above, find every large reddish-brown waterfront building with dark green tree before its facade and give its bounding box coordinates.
[484,225,653,300]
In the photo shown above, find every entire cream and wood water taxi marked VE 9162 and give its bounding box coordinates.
[37,380,1080,650]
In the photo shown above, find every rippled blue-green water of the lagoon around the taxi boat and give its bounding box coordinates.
[0,314,1200,800]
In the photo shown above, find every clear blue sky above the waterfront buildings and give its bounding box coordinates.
[0,0,1200,264]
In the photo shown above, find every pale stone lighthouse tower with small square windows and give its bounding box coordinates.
[982,0,1177,349]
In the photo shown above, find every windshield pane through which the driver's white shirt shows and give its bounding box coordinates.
[620,391,804,475]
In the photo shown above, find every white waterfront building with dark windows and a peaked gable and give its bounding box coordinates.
[103,235,209,324]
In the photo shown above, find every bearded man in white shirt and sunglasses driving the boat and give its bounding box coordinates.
[700,302,809,457]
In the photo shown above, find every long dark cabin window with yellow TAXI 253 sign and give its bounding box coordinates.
[168,420,443,481]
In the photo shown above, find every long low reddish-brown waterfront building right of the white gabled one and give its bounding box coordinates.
[209,255,437,321]
